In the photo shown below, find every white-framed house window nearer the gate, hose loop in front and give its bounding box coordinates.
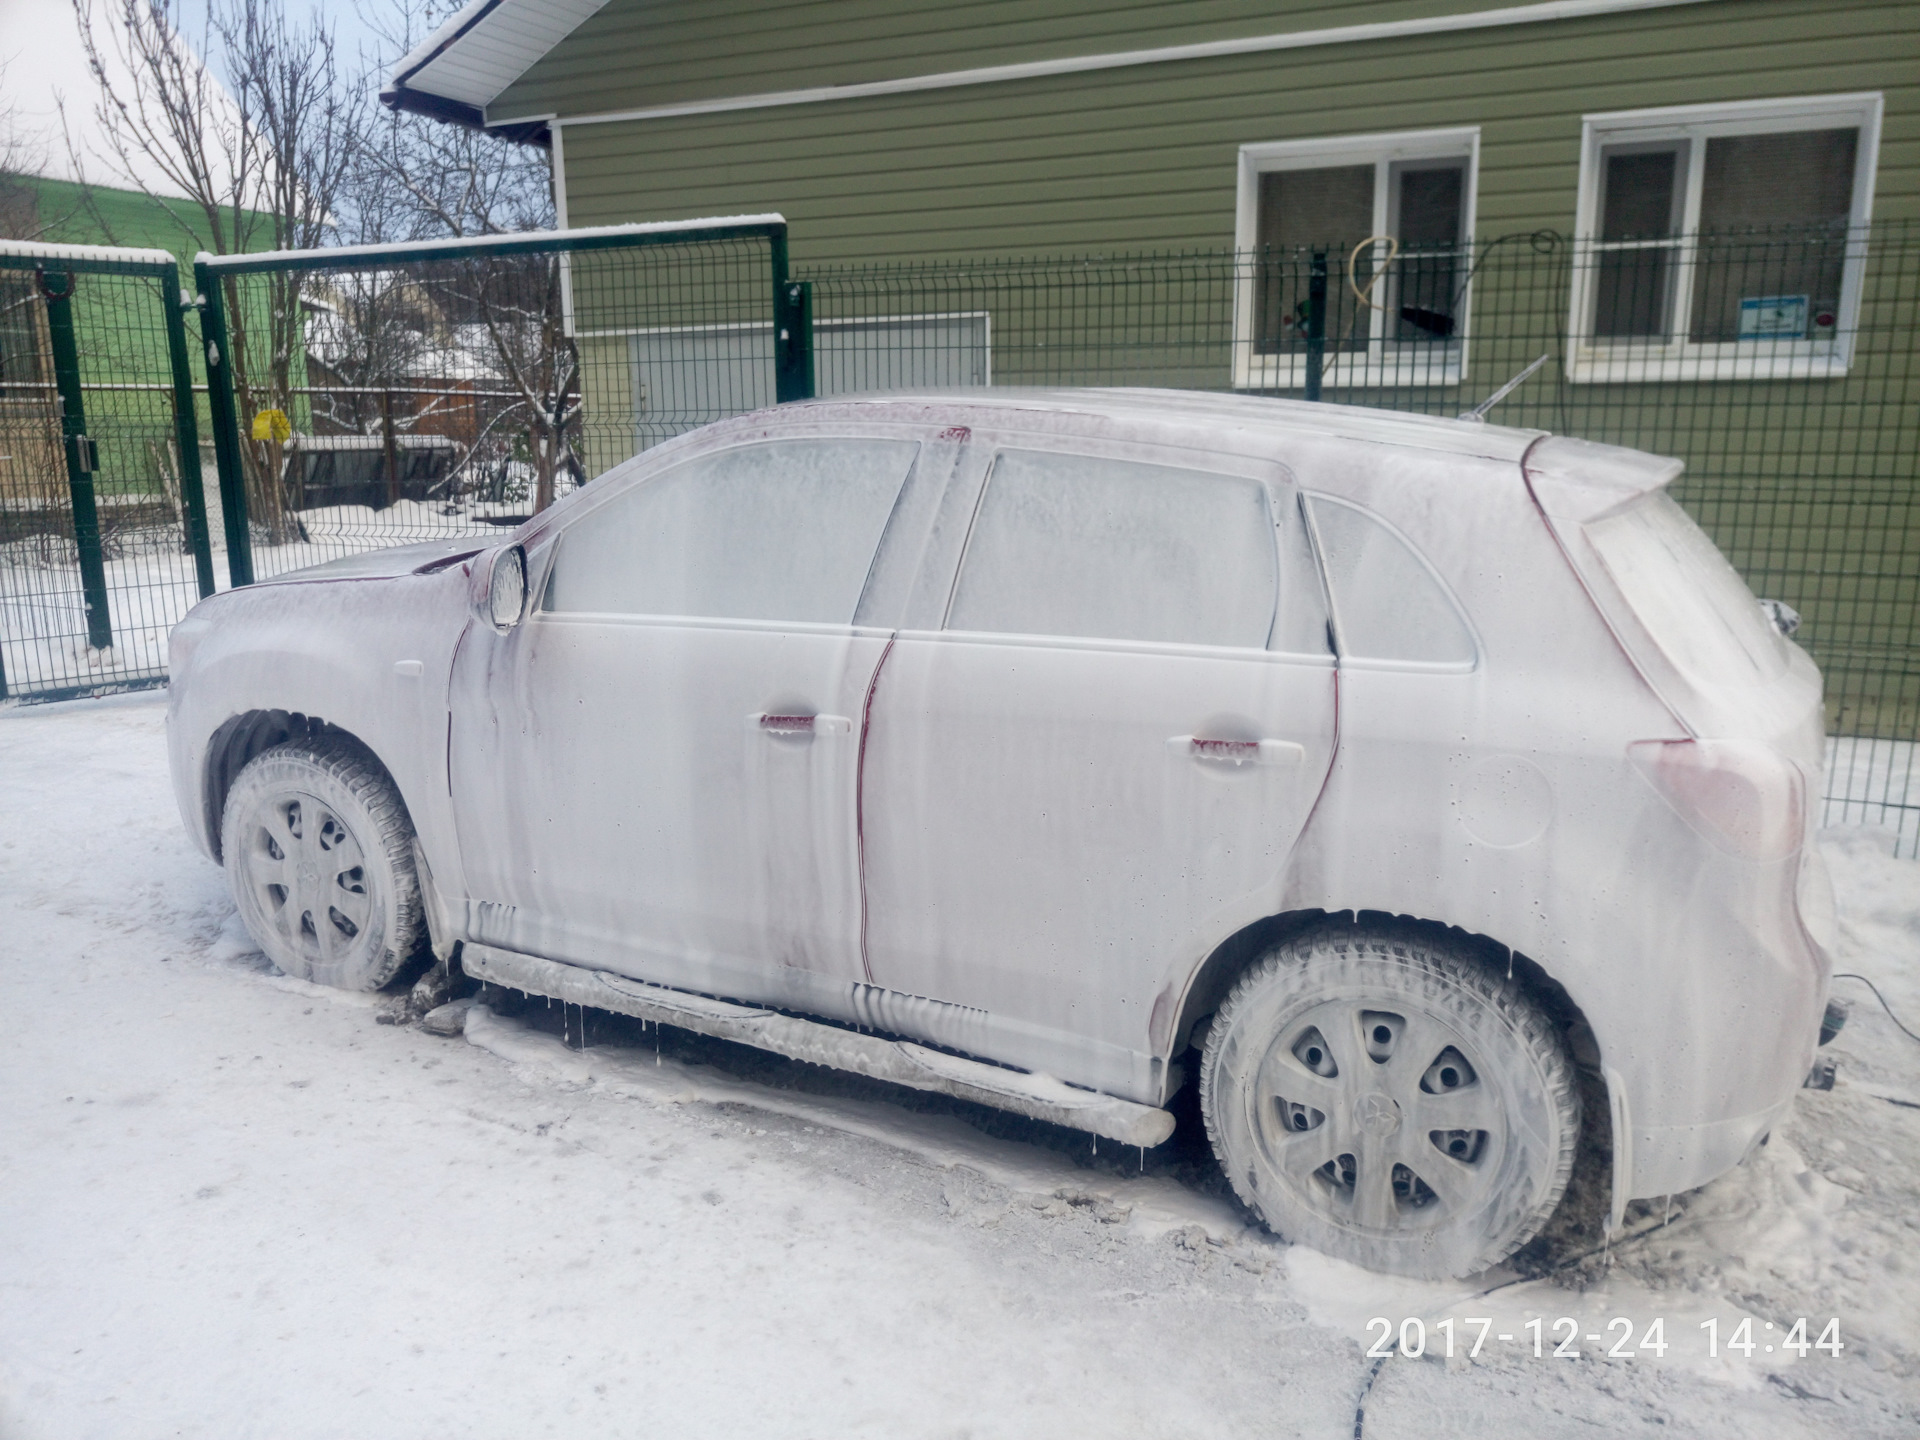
[1235,131,1480,390]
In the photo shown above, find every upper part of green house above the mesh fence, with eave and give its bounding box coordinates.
[386,0,1920,261]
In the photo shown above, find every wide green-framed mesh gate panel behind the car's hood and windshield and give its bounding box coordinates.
[200,217,797,578]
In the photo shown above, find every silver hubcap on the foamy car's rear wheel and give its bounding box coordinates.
[1250,1000,1507,1233]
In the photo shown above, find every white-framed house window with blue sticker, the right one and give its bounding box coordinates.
[1571,96,1880,382]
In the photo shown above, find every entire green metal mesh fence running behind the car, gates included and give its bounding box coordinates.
[30,217,1920,852]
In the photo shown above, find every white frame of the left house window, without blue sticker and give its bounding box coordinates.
[1233,125,1480,390]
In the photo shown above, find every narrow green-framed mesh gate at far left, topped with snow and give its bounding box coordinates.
[0,240,215,701]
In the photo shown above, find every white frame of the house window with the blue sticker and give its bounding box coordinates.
[1567,92,1885,384]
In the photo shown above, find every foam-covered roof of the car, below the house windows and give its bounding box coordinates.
[783,386,1548,463]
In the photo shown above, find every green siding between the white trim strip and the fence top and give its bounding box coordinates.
[528,0,1920,261]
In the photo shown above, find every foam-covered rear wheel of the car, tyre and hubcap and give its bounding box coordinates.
[1200,925,1580,1279]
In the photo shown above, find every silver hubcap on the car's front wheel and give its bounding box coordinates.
[246,795,372,964]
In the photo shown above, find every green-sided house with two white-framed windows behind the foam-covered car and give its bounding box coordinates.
[382,0,1920,818]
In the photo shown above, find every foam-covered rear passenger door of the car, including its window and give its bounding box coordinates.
[862,440,1334,1098]
